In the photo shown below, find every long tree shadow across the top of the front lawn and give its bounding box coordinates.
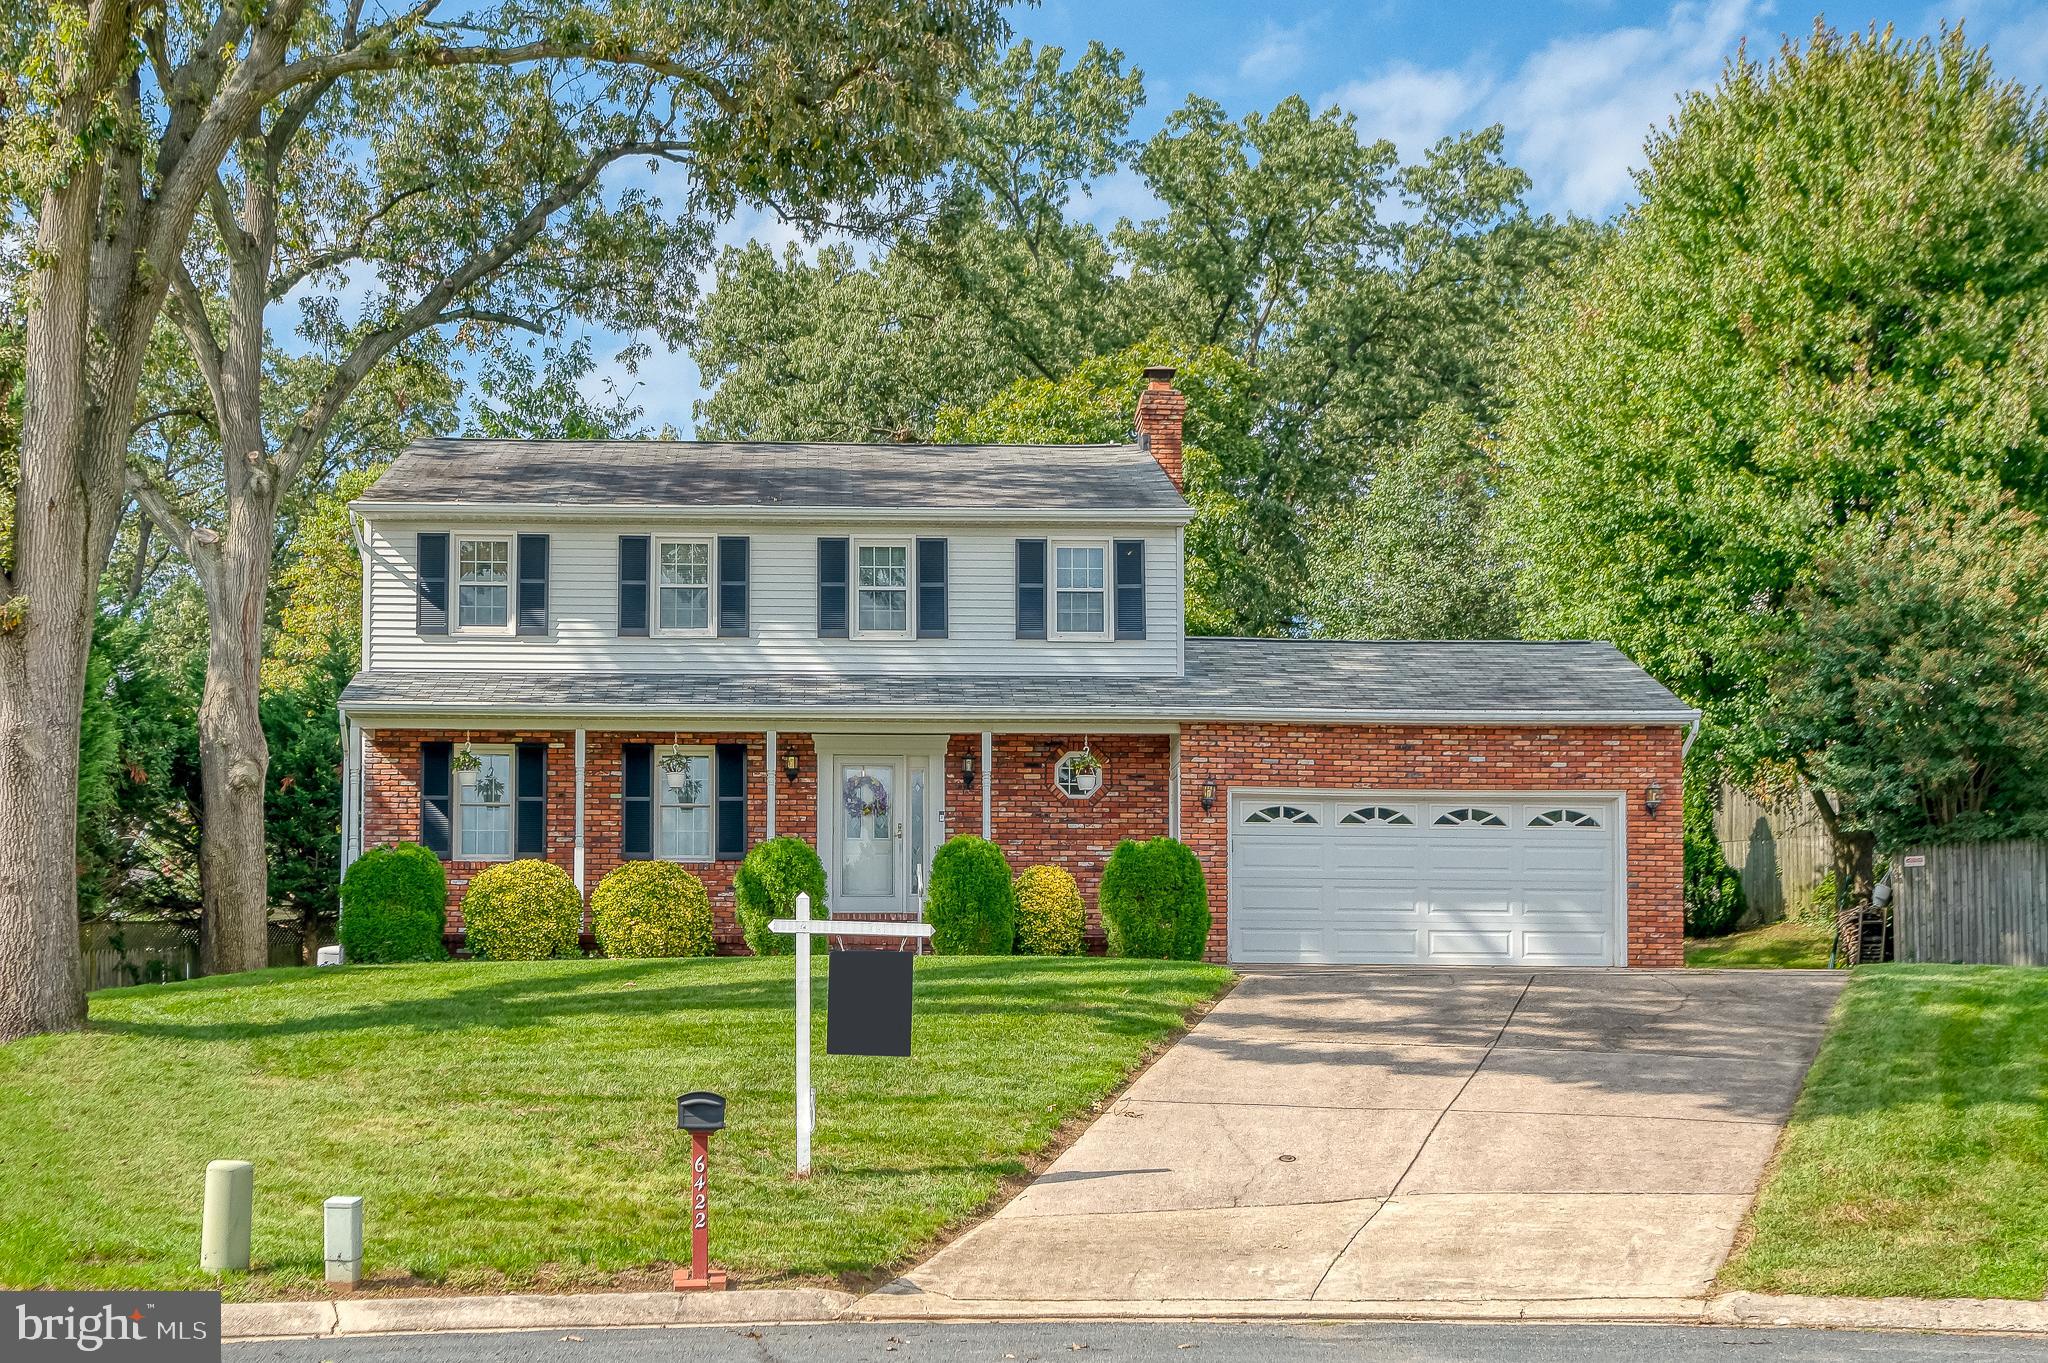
[92,958,1212,1042]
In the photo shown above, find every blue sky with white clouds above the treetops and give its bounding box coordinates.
[594,0,2048,432]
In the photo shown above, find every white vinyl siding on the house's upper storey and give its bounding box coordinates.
[365,516,1184,688]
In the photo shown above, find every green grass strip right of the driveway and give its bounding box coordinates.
[1720,966,2048,1300]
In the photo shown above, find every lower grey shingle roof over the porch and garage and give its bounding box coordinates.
[342,639,1694,724]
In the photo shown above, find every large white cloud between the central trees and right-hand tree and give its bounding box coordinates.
[1329,0,1778,217]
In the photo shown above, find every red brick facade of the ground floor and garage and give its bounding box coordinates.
[365,724,1686,966]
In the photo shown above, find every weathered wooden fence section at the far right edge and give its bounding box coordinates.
[1892,843,2048,966]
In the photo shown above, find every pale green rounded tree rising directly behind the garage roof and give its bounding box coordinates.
[1307,403,1518,639]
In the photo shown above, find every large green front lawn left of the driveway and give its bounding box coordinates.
[0,958,1231,1298]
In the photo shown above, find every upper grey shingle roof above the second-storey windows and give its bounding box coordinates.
[358,440,1186,512]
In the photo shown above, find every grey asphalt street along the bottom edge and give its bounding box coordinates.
[225,1320,2048,1363]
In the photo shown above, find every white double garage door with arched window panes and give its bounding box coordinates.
[1231,794,1620,966]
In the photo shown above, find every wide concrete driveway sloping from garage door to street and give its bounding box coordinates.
[877,968,1843,1314]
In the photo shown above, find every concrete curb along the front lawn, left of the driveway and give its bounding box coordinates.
[221,1287,858,1338]
